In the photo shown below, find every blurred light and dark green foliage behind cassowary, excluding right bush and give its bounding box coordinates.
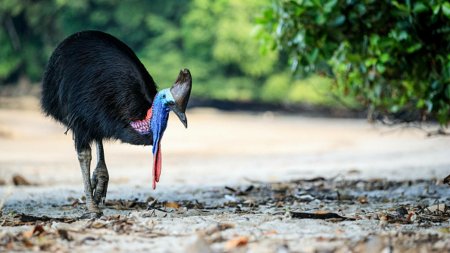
[0,0,356,109]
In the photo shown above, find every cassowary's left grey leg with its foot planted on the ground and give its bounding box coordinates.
[78,147,101,217]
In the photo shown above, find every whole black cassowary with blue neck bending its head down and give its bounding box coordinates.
[41,31,192,217]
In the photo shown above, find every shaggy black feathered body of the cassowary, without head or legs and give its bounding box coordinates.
[41,31,157,150]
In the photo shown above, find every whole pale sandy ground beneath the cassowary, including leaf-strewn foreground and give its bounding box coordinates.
[0,97,450,252]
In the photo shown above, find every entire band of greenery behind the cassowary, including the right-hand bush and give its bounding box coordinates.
[0,0,450,122]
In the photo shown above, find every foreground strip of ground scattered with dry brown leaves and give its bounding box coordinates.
[0,177,450,252]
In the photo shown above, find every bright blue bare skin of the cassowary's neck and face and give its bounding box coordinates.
[149,89,175,155]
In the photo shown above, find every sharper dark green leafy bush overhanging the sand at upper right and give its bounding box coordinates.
[258,0,450,125]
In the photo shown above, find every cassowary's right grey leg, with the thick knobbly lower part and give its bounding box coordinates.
[91,141,109,204]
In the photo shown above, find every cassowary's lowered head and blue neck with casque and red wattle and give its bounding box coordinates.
[150,69,192,189]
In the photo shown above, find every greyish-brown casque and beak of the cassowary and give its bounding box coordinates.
[170,69,192,128]
